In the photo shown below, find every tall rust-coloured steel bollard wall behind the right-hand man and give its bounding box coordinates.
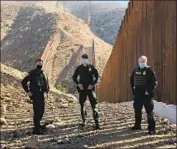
[97,0,177,104]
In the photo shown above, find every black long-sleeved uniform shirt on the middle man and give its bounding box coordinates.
[72,64,99,88]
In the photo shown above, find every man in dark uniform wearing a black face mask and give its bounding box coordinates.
[21,59,49,134]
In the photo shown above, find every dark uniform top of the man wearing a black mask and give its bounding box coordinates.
[21,68,49,93]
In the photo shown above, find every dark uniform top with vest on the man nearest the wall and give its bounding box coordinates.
[130,66,157,96]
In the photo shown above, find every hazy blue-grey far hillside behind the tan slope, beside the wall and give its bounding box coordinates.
[59,1,126,45]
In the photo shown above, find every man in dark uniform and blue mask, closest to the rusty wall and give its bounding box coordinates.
[130,56,157,135]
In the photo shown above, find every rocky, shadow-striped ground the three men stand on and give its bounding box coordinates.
[1,65,176,149]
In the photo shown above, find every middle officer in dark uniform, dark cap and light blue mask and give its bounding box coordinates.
[72,54,100,129]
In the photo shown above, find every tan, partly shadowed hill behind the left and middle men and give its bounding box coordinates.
[1,2,112,90]
